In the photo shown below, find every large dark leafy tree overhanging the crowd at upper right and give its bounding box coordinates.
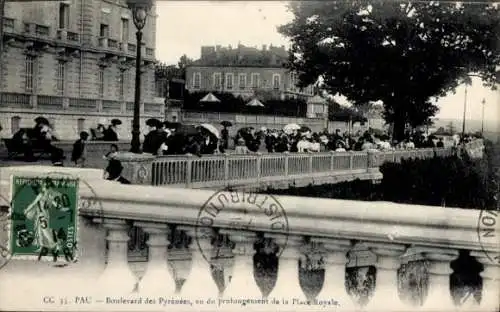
[279,0,500,140]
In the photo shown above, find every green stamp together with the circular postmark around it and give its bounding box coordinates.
[0,172,103,268]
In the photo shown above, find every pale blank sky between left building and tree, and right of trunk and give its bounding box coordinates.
[156,0,500,129]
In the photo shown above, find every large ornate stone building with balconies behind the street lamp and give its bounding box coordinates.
[0,0,164,140]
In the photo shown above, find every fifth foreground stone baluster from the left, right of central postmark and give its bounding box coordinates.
[266,234,306,301]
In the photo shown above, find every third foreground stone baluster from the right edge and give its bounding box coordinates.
[368,243,405,311]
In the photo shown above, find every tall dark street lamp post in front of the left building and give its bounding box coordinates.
[127,0,152,154]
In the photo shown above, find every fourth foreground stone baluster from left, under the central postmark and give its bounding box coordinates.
[220,230,262,299]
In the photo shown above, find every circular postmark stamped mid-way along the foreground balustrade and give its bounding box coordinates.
[195,191,289,263]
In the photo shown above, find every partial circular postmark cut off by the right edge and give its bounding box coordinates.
[477,204,500,264]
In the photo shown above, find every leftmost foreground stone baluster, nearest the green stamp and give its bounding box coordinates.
[99,219,137,294]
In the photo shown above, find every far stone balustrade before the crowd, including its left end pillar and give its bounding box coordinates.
[119,148,454,190]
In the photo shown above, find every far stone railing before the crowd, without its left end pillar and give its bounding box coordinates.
[145,148,454,188]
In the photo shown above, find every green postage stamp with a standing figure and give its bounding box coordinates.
[9,176,79,262]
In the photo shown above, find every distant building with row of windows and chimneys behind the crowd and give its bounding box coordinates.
[186,45,327,116]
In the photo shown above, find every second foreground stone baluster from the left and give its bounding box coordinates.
[134,222,175,296]
